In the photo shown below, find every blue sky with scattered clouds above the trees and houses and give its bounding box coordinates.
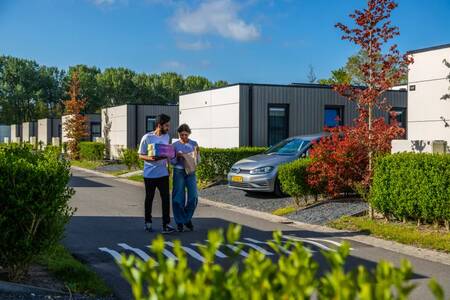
[0,0,450,84]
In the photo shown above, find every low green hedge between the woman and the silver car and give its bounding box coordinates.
[197,147,266,182]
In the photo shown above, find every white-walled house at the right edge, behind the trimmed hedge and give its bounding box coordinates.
[392,44,450,152]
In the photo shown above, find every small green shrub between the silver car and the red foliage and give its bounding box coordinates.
[278,158,319,206]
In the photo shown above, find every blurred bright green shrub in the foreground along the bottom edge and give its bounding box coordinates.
[120,226,443,300]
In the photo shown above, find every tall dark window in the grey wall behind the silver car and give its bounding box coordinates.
[268,104,289,146]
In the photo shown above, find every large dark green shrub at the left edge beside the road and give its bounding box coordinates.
[0,146,73,280]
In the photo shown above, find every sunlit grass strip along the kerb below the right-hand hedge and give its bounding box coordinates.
[328,216,450,253]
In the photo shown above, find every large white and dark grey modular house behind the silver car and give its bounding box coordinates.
[179,83,407,148]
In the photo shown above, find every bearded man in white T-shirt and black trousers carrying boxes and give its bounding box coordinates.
[139,114,175,233]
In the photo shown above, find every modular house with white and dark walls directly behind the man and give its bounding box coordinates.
[102,104,179,159]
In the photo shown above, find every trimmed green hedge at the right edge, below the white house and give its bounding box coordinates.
[369,153,450,228]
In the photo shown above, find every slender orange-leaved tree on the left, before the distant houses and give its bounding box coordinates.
[64,72,88,159]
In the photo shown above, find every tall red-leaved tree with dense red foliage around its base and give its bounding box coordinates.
[309,0,412,211]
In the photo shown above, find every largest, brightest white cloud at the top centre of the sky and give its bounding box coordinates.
[171,0,260,41]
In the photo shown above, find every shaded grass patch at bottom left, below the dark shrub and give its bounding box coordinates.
[38,245,112,296]
